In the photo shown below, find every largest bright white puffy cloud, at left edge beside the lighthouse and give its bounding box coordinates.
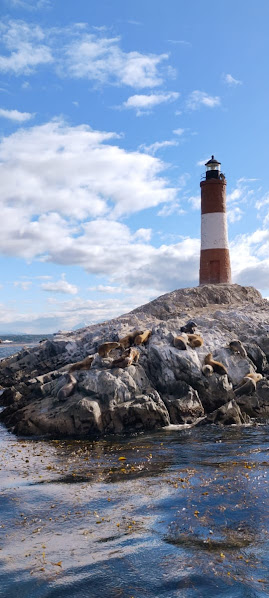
[0,121,176,240]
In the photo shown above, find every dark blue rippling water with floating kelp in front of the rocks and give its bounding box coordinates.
[0,426,269,598]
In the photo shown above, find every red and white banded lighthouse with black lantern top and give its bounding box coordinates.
[200,156,231,285]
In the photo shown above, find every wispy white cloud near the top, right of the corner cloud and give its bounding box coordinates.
[62,32,168,89]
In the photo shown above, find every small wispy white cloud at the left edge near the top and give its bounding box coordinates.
[0,21,53,75]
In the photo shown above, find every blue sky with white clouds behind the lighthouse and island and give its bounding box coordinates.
[0,0,269,334]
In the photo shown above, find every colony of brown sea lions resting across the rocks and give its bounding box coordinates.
[58,321,263,400]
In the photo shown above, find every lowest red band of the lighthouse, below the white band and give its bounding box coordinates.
[199,249,232,284]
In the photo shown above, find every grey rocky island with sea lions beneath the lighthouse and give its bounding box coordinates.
[0,284,269,437]
